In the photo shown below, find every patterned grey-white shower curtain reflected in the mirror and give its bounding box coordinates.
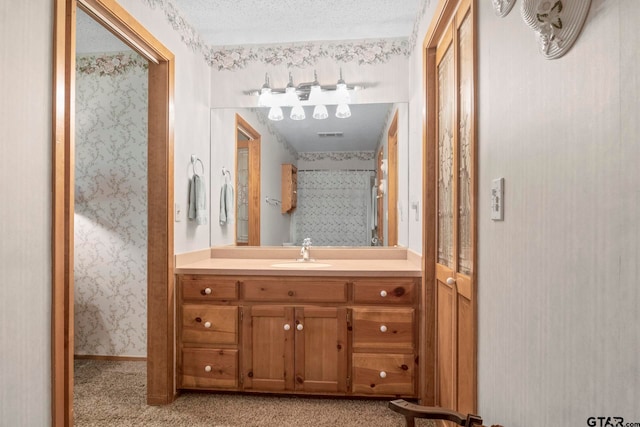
[293,170,375,246]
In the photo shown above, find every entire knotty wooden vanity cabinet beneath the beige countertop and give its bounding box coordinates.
[178,275,419,398]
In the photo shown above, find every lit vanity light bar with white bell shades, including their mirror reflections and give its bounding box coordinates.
[249,69,364,121]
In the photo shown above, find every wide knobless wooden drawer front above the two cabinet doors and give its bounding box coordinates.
[243,278,347,303]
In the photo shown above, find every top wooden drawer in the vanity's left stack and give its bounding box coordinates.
[180,274,238,302]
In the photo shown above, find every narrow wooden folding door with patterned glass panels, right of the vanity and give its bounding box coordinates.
[434,1,476,413]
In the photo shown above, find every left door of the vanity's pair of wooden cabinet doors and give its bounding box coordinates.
[243,305,296,391]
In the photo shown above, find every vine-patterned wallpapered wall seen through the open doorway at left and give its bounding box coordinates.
[74,52,148,356]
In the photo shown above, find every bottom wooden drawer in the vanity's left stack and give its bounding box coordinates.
[180,348,238,389]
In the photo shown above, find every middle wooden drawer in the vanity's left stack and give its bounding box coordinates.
[182,304,238,344]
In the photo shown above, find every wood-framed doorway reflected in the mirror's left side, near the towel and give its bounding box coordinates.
[236,115,260,246]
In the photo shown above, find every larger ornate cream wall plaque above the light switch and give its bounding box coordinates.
[524,0,591,59]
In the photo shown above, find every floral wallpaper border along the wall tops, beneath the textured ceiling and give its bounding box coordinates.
[142,0,432,71]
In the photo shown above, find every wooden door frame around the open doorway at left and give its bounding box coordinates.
[51,0,175,427]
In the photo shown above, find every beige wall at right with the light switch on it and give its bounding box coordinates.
[478,0,640,427]
